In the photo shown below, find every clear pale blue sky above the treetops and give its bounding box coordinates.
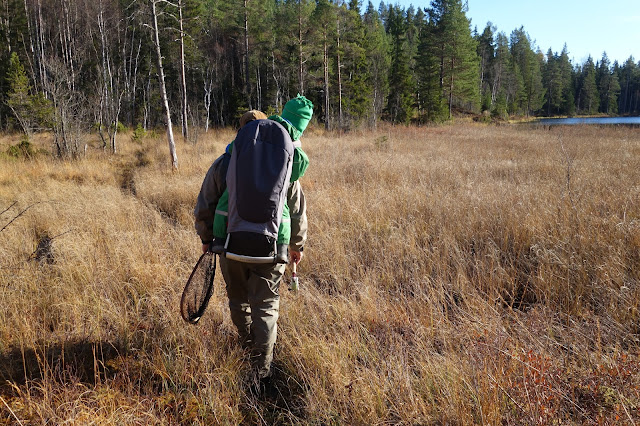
[384,0,640,64]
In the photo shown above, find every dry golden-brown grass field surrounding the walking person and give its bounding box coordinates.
[0,124,640,425]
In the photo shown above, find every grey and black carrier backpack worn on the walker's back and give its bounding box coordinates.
[225,120,294,263]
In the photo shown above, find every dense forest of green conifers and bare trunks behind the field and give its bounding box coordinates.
[0,0,640,153]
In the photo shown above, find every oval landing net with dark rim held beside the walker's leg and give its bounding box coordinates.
[180,252,216,324]
